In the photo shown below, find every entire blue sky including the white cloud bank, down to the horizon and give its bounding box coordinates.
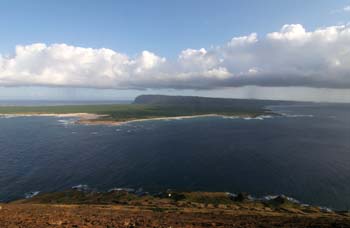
[0,0,350,102]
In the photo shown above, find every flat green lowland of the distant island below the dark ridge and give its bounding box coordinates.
[0,104,265,121]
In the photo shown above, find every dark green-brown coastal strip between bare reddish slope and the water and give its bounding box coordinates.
[16,189,340,216]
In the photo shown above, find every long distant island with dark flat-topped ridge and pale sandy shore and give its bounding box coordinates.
[0,95,291,125]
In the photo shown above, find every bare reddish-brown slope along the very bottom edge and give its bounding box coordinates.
[0,201,350,228]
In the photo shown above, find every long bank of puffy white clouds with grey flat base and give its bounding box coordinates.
[0,24,350,89]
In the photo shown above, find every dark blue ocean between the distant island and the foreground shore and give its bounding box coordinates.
[0,104,350,209]
